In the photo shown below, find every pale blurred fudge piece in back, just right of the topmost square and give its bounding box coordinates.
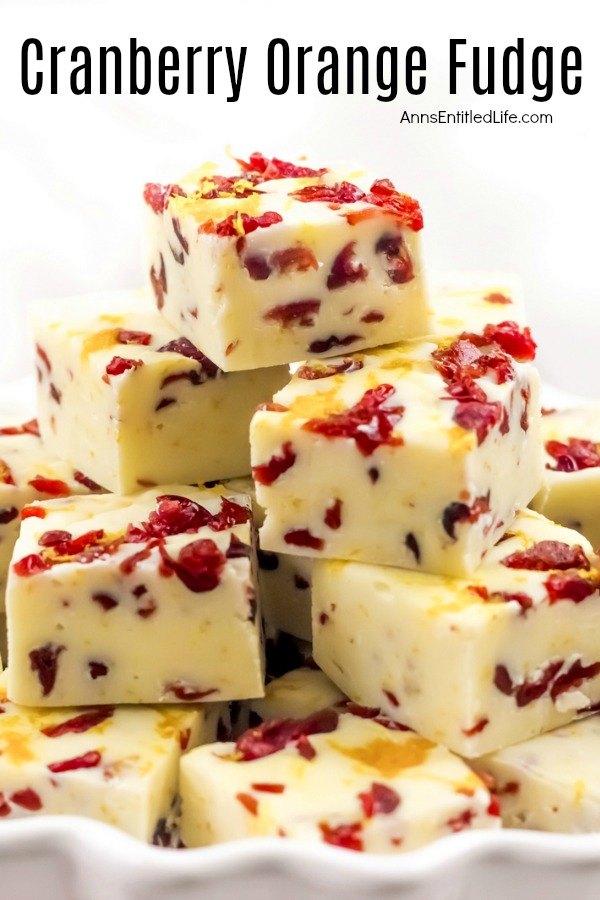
[428,272,527,337]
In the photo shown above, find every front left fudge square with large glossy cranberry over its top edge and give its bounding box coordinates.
[6,485,264,706]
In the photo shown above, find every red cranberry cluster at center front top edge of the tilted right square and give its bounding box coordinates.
[302,384,404,456]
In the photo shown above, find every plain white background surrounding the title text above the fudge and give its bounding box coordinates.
[0,0,600,396]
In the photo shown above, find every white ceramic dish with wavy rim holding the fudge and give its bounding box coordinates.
[0,381,600,900]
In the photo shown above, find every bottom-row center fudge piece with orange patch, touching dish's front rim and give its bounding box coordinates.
[181,705,500,853]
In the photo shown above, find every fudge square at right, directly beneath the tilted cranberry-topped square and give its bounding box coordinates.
[313,510,600,757]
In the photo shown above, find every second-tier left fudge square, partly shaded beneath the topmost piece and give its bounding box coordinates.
[34,291,288,494]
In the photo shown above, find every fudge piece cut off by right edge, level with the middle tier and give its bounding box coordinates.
[531,405,600,547]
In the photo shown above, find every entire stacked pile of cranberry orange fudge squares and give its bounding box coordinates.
[0,153,600,853]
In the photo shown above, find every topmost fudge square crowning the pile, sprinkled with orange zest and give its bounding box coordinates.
[144,153,428,371]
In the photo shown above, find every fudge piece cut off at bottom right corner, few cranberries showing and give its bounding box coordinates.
[473,715,600,833]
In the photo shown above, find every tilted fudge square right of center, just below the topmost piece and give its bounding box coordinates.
[250,321,542,575]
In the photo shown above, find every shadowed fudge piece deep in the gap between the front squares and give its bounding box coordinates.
[224,477,314,641]
